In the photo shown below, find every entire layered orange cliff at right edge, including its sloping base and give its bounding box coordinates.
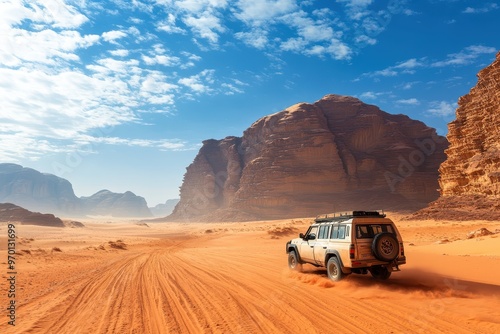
[414,52,500,219]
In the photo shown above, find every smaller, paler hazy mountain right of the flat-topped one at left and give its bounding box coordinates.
[81,190,152,217]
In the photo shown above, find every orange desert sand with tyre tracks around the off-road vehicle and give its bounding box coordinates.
[0,214,500,334]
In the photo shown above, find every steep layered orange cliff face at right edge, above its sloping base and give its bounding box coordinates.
[439,53,500,199]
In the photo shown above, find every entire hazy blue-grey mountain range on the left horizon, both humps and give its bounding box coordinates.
[0,163,152,217]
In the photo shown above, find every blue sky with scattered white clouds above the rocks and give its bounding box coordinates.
[0,0,500,206]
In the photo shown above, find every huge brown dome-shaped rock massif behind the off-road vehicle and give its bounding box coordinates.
[167,95,447,220]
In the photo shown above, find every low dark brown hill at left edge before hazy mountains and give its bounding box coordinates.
[0,203,65,227]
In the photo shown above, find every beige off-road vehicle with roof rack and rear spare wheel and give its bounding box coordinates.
[286,211,406,281]
